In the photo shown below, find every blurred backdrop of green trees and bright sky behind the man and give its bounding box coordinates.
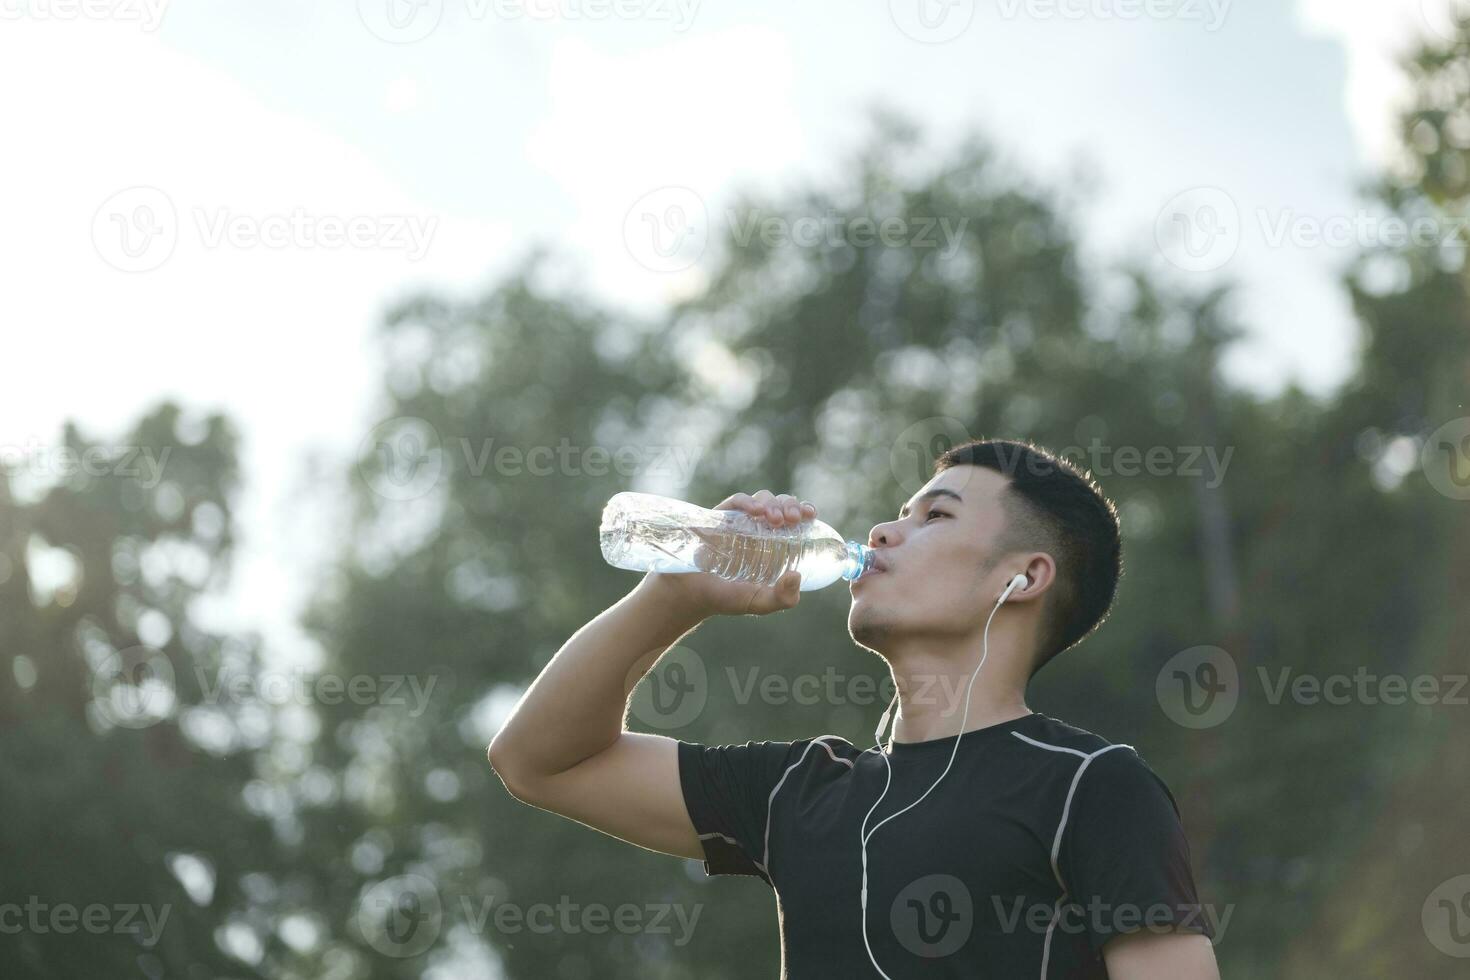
[0,0,1470,980]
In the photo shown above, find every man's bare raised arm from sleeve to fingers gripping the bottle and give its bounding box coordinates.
[488,491,816,858]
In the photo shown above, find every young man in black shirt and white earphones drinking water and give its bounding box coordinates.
[490,441,1219,980]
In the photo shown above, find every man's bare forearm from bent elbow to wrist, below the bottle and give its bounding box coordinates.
[490,576,704,782]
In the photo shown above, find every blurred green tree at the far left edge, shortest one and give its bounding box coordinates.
[0,404,272,979]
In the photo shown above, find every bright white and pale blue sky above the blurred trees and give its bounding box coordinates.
[0,0,1449,667]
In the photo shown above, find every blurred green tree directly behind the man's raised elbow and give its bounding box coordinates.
[291,259,699,977]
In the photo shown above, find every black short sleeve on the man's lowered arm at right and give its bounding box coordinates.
[1057,745,1216,952]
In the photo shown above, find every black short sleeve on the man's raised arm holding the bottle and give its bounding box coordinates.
[679,742,803,884]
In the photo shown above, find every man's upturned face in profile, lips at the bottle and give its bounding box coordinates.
[847,466,1020,652]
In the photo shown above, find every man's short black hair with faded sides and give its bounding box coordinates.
[933,439,1123,674]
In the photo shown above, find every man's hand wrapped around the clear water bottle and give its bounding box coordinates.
[638,489,817,619]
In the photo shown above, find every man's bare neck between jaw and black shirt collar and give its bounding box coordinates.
[885,629,1032,742]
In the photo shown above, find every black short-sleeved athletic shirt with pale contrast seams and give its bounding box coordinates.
[679,713,1216,980]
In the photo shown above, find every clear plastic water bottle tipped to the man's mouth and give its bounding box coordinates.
[601,492,873,592]
